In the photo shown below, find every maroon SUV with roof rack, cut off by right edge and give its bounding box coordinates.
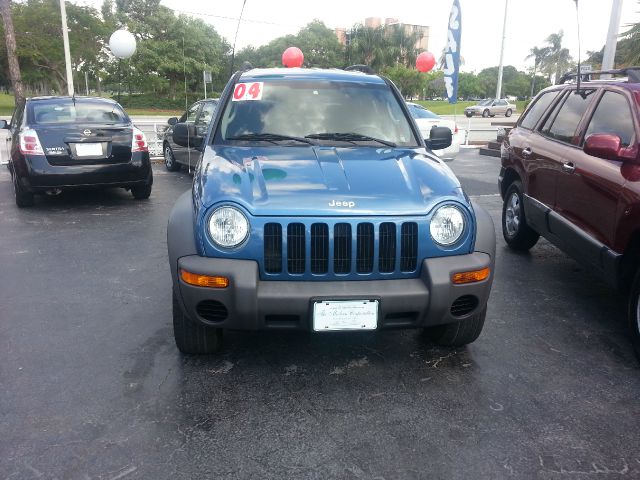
[499,67,640,358]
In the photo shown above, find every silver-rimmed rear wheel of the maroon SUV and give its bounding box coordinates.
[502,180,540,251]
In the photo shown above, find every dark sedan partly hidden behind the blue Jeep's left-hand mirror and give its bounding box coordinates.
[162,98,218,172]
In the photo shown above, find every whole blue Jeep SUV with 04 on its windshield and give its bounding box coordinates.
[167,69,495,353]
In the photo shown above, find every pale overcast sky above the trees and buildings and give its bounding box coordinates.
[79,0,640,73]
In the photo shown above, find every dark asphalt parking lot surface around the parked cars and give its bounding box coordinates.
[0,150,640,480]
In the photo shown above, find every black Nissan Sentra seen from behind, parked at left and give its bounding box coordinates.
[0,97,153,207]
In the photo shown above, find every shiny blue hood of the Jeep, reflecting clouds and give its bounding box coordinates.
[194,146,467,216]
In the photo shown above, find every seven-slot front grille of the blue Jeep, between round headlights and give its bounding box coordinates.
[263,222,418,275]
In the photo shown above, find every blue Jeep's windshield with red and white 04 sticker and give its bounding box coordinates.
[214,78,419,147]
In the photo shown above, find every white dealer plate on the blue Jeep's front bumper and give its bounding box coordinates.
[313,300,378,332]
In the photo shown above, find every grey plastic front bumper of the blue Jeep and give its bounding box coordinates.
[176,252,494,330]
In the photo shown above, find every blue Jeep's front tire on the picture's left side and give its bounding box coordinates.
[173,291,222,355]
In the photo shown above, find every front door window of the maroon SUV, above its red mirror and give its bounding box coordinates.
[585,91,635,147]
